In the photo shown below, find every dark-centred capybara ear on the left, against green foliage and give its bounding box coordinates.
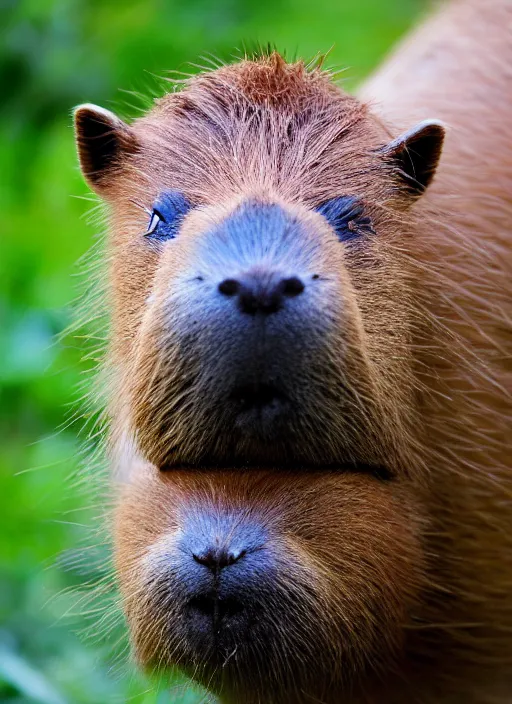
[75,103,137,197]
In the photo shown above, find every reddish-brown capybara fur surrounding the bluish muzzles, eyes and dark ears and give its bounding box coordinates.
[77,0,512,704]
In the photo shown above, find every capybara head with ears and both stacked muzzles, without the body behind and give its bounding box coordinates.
[76,54,444,703]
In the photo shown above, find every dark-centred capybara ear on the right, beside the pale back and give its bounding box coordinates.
[380,120,446,198]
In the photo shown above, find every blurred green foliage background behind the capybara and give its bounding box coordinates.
[0,0,425,704]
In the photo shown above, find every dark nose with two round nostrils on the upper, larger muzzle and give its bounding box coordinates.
[218,267,305,315]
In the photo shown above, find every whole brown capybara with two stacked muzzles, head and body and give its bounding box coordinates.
[76,0,512,704]
